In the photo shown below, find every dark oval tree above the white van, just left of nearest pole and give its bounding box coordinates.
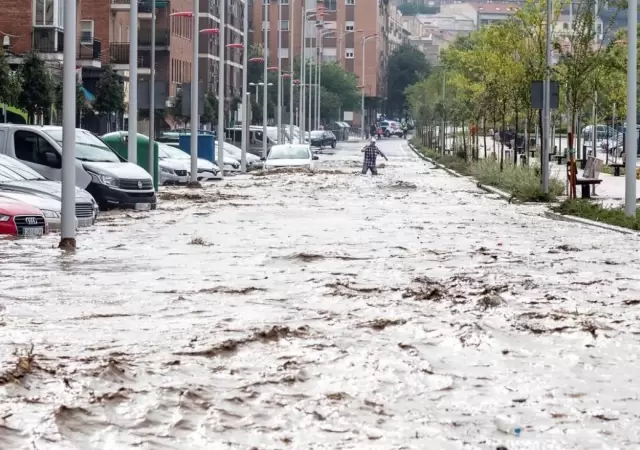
[18,53,53,123]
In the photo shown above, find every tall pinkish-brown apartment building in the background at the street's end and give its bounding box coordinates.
[249,0,390,121]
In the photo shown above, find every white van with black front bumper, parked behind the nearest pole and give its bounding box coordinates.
[0,124,156,210]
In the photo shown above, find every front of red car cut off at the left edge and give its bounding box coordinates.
[0,198,49,237]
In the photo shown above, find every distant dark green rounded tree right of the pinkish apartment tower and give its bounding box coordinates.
[387,44,431,115]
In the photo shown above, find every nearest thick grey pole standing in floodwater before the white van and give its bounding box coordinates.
[60,0,77,250]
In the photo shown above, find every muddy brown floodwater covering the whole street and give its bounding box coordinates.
[0,139,640,450]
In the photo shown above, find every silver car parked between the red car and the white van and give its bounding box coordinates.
[0,155,98,228]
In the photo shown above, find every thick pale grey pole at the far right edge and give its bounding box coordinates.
[624,0,638,217]
